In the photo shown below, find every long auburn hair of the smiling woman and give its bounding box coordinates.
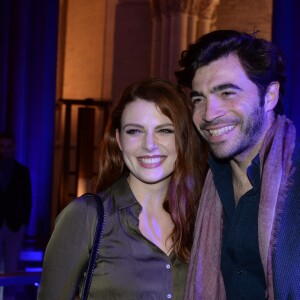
[96,78,208,262]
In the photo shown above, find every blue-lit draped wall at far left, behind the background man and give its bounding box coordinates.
[0,0,58,236]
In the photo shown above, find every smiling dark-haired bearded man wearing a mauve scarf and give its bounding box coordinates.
[176,30,300,300]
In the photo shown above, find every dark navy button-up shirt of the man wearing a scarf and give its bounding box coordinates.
[209,155,266,300]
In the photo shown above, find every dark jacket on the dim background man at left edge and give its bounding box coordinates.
[0,161,32,232]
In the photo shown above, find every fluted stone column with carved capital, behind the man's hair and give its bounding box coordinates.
[150,0,219,81]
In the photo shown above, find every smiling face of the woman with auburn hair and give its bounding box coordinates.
[116,99,177,184]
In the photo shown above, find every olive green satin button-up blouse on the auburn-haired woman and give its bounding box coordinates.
[38,177,188,300]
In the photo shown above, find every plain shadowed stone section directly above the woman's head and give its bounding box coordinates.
[112,0,152,101]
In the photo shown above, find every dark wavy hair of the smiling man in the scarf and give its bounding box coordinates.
[175,30,286,114]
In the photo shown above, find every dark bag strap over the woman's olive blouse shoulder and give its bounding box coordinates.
[81,193,105,300]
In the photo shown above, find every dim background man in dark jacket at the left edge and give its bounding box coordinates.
[0,133,31,299]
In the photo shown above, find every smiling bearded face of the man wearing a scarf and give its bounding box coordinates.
[191,54,270,159]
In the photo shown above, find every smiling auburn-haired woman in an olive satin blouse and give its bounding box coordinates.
[38,79,207,300]
